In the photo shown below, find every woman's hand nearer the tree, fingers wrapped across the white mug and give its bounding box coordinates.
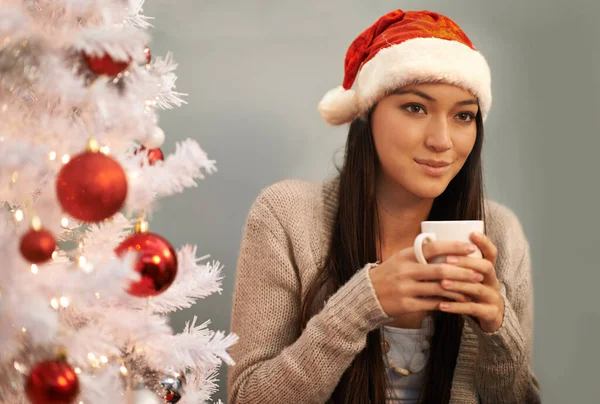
[369,241,483,317]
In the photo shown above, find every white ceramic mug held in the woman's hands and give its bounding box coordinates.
[414,220,484,264]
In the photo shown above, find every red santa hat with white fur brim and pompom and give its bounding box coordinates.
[319,10,492,125]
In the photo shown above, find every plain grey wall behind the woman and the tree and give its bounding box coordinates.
[145,0,600,404]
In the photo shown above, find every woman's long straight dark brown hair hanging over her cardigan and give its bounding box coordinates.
[302,107,484,404]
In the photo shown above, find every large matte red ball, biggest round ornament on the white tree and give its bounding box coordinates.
[56,151,127,222]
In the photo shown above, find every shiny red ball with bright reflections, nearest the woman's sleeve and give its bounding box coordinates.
[115,233,177,297]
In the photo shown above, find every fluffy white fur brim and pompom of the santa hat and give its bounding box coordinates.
[319,38,492,125]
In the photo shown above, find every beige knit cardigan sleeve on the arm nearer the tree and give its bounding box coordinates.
[228,200,389,404]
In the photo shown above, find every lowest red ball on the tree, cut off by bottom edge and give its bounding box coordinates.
[25,360,79,404]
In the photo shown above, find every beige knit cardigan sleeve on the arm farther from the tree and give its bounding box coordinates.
[467,207,540,404]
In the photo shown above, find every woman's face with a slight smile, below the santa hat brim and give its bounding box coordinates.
[371,84,479,199]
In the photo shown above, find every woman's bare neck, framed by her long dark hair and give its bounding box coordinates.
[376,177,433,260]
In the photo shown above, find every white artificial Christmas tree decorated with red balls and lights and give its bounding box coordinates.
[0,0,237,404]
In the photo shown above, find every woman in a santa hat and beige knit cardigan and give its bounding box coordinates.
[228,10,540,404]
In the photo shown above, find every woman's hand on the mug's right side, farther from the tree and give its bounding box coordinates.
[439,233,504,333]
